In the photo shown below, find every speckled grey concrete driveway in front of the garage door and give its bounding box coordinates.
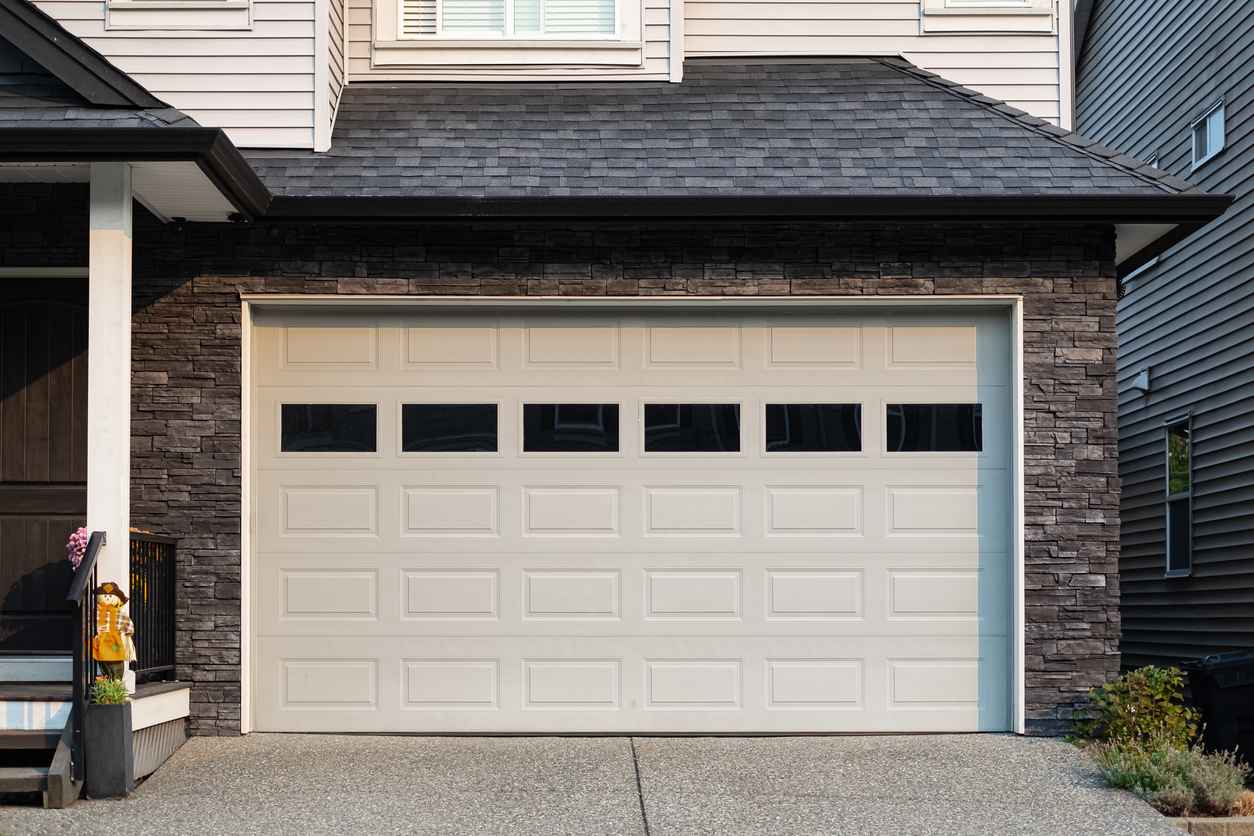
[0,734,1179,836]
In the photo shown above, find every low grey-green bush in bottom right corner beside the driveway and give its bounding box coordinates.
[1088,738,1249,816]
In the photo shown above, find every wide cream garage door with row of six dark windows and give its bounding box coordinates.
[251,307,1012,732]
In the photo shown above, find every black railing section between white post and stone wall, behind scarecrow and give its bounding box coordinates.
[130,531,177,683]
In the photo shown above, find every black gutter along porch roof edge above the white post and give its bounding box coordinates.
[0,127,271,218]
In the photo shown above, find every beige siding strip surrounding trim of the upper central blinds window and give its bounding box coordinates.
[345,0,671,81]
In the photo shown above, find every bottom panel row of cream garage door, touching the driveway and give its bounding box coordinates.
[257,637,1008,732]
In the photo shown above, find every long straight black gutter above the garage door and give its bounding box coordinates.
[265,193,1233,224]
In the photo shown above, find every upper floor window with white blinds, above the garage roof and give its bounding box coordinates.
[401,0,618,40]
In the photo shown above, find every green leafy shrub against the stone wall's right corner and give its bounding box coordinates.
[1077,666,1198,748]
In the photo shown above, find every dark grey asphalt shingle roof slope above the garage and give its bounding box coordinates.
[245,58,1191,198]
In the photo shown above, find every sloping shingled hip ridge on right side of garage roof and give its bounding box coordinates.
[870,56,1204,194]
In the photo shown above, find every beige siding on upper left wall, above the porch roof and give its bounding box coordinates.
[36,0,318,148]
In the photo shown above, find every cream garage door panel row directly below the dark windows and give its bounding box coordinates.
[255,471,1009,554]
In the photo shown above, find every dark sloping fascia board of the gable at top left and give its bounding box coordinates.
[0,0,169,109]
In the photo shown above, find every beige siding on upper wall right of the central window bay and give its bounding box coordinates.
[683,0,1060,122]
